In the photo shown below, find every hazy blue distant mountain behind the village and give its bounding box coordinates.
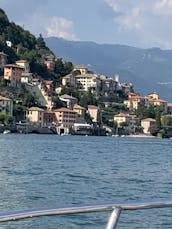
[44,37,172,101]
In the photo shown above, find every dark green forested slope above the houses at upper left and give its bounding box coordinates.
[0,9,73,81]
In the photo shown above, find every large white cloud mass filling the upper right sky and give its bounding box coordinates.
[104,0,172,48]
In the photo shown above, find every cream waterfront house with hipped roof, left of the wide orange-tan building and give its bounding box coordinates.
[26,107,44,127]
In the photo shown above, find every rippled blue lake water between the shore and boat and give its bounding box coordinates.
[0,135,172,229]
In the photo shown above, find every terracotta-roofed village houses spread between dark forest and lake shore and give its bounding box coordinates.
[0,52,172,135]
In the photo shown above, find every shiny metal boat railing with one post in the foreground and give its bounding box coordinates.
[0,201,172,229]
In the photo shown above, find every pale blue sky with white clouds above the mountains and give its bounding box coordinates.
[0,0,172,49]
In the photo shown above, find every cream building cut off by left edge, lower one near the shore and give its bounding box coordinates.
[0,96,13,115]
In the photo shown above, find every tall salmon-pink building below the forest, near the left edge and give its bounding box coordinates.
[4,64,23,86]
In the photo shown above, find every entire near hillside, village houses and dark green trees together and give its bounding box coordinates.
[0,10,172,137]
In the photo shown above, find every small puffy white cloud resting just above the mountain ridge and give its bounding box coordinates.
[46,17,77,40]
